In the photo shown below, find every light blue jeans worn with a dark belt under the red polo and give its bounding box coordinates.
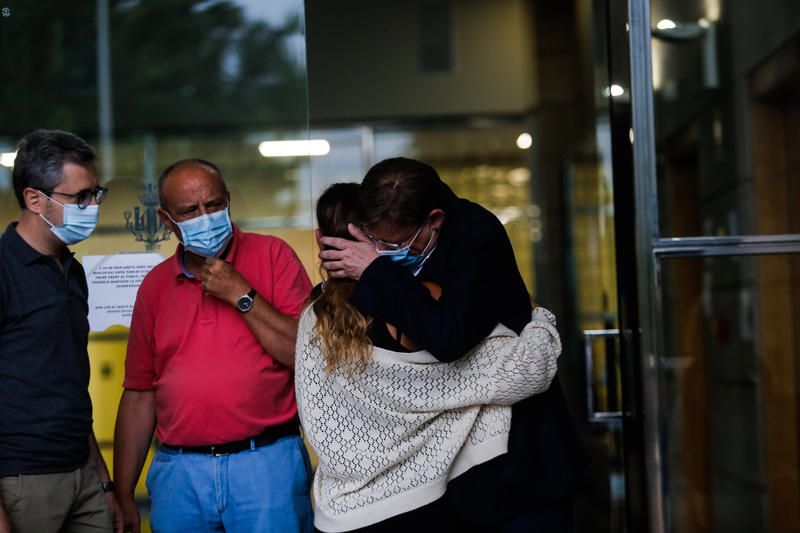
[147,436,313,533]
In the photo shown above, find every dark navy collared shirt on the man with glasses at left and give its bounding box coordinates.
[0,223,92,477]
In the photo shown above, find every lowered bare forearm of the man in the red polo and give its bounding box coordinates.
[114,389,156,498]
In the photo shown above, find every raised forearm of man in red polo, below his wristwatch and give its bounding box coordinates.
[243,296,297,368]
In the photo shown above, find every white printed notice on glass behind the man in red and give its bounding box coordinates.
[83,253,164,331]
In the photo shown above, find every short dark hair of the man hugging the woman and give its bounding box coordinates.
[361,157,442,226]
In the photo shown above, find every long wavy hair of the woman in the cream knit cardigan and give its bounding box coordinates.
[311,183,372,372]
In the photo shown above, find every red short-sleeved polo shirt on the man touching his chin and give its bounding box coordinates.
[123,227,311,446]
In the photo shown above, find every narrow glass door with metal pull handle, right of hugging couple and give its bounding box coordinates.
[556,0,646,533]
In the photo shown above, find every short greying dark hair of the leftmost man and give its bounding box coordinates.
[13,130,97,209]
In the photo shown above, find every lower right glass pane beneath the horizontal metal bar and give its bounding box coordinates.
[659,255,800,533]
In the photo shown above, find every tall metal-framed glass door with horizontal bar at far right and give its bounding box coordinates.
[628,0,800,533]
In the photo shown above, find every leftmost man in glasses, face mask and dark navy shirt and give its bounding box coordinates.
[0,130,121,533]
